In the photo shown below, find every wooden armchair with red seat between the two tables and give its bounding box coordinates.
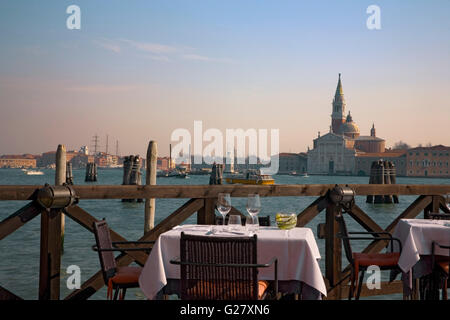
[336,214,402,300]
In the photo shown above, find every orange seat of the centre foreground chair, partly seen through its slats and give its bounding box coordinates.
[188,280,269,300]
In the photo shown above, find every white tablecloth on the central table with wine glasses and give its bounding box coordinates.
[139,225,327,299]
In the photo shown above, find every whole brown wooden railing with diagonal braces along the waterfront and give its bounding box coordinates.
[0,184,450,300]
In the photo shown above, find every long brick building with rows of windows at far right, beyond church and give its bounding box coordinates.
[406,145,450,178]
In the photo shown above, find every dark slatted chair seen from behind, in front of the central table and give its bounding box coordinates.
[170,232,278,300]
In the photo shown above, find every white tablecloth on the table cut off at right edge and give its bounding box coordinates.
[393,219,450,272]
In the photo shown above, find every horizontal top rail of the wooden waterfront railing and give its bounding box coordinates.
[0,184,450,200]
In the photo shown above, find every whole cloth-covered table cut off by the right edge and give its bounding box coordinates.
[392,219,450,298]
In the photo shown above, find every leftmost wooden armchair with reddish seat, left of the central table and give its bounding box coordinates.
[92,220,154,300]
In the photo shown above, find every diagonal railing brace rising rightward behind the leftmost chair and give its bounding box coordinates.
[65,199,203,300]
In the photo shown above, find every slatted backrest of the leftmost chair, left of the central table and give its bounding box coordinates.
[93,220,117,284]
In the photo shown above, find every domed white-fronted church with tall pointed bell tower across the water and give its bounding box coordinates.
[307,74,385,175]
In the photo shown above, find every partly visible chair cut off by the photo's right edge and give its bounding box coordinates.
[431,241,450,300]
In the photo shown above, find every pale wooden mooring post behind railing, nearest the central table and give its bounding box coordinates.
[144,141,158,233]
